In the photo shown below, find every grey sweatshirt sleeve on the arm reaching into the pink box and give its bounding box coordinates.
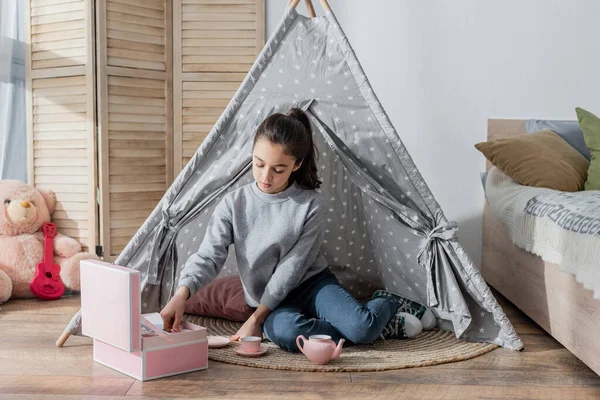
[178,201,233,296]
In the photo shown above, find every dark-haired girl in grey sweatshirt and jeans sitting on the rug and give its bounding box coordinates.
[161,108,435,351]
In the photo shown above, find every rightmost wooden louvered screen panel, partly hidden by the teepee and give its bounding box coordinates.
[173,0,264,168]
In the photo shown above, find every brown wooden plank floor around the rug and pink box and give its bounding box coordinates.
[0,296,600,400]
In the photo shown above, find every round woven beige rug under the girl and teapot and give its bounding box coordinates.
[184,315,498,372]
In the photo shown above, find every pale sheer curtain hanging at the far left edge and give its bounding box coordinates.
[0,0,27,181]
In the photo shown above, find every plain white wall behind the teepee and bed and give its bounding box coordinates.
[267,0,600,266]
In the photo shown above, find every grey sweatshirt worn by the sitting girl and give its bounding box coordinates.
[179,182,327,310]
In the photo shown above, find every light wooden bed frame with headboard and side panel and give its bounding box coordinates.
[482,119,600,375]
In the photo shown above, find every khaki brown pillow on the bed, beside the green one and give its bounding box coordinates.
[475,130,590,192]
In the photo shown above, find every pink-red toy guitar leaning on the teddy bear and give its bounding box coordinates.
[29,222,65,300]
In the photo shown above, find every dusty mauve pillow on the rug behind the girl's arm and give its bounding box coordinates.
[185,275,254,322]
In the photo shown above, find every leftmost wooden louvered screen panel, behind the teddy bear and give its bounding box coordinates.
[24,0,98,251]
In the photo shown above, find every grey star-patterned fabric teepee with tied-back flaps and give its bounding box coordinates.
[59,0,522,349]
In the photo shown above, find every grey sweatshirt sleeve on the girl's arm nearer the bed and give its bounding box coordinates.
[260,199,324,311]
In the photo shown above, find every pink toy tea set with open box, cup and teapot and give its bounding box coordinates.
[80,260,344,381]
